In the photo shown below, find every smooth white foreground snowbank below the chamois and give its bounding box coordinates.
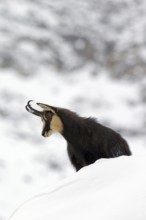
[10,156,146,220]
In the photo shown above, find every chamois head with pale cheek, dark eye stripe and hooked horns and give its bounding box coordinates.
[25,100,63,137]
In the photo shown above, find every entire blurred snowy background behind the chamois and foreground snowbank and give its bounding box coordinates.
[0,0,146,220]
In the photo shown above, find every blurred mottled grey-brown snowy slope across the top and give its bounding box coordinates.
[0,0,146,78]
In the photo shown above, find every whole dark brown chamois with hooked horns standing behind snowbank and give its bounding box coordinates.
[26,100,131,171]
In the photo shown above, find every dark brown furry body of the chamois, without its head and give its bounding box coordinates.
[57,109,131,171]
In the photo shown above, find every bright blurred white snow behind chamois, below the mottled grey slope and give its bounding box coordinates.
[0,71,146,220]
